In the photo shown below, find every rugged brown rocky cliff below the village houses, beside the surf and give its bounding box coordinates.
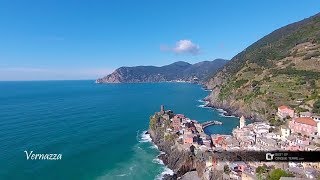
[148,113,221,179]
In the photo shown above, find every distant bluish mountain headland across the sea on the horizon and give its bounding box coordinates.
[96,59,227,83]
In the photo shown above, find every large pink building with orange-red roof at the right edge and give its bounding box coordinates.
[289,117,318,136]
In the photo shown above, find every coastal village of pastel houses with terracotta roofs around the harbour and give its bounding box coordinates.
[150,105,320,180]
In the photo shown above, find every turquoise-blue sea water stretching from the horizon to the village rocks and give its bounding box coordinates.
[0,81,238,180]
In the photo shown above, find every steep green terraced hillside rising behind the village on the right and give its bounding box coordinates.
[206,14,320,120]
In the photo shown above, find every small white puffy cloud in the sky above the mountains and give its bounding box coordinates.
[160,39,200,55]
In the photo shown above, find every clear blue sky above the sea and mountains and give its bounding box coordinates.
[0,0,320,80]
